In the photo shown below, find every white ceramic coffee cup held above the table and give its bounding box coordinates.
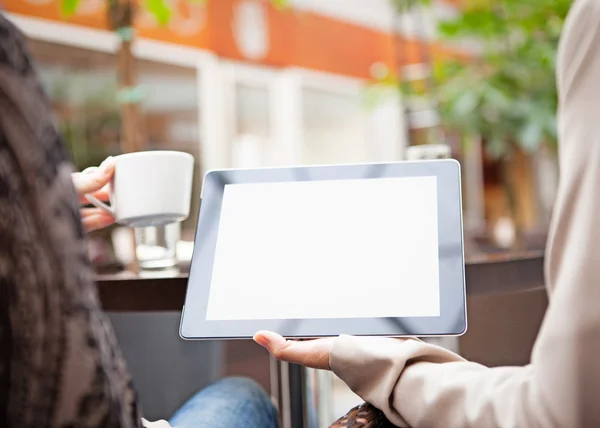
[86,151,194,227]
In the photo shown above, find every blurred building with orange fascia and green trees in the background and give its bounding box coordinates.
[0,0,571,424]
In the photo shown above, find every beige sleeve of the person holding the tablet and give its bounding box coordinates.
[330,0,600,428]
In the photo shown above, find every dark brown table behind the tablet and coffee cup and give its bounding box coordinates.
[97,251,544,428]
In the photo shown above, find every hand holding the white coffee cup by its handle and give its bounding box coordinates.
[72,157,115,232]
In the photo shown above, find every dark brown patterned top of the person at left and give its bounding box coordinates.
[0,14,141,428]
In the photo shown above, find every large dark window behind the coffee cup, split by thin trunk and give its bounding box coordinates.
[29,40,202,244]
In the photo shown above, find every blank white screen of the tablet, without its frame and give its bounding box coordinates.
[206,177,440,320]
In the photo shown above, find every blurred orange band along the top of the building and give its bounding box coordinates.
[4,0,462,78]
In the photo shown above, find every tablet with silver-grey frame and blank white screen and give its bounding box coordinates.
[180,160,467,339]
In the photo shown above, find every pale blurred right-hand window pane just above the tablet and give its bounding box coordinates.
[302,88,372,164]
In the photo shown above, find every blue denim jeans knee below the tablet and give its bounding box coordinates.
[169,377,279,428]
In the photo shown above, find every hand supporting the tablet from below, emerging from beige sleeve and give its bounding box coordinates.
[254,331,335,370]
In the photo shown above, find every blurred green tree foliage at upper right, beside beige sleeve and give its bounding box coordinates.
[395,0,572,158]
